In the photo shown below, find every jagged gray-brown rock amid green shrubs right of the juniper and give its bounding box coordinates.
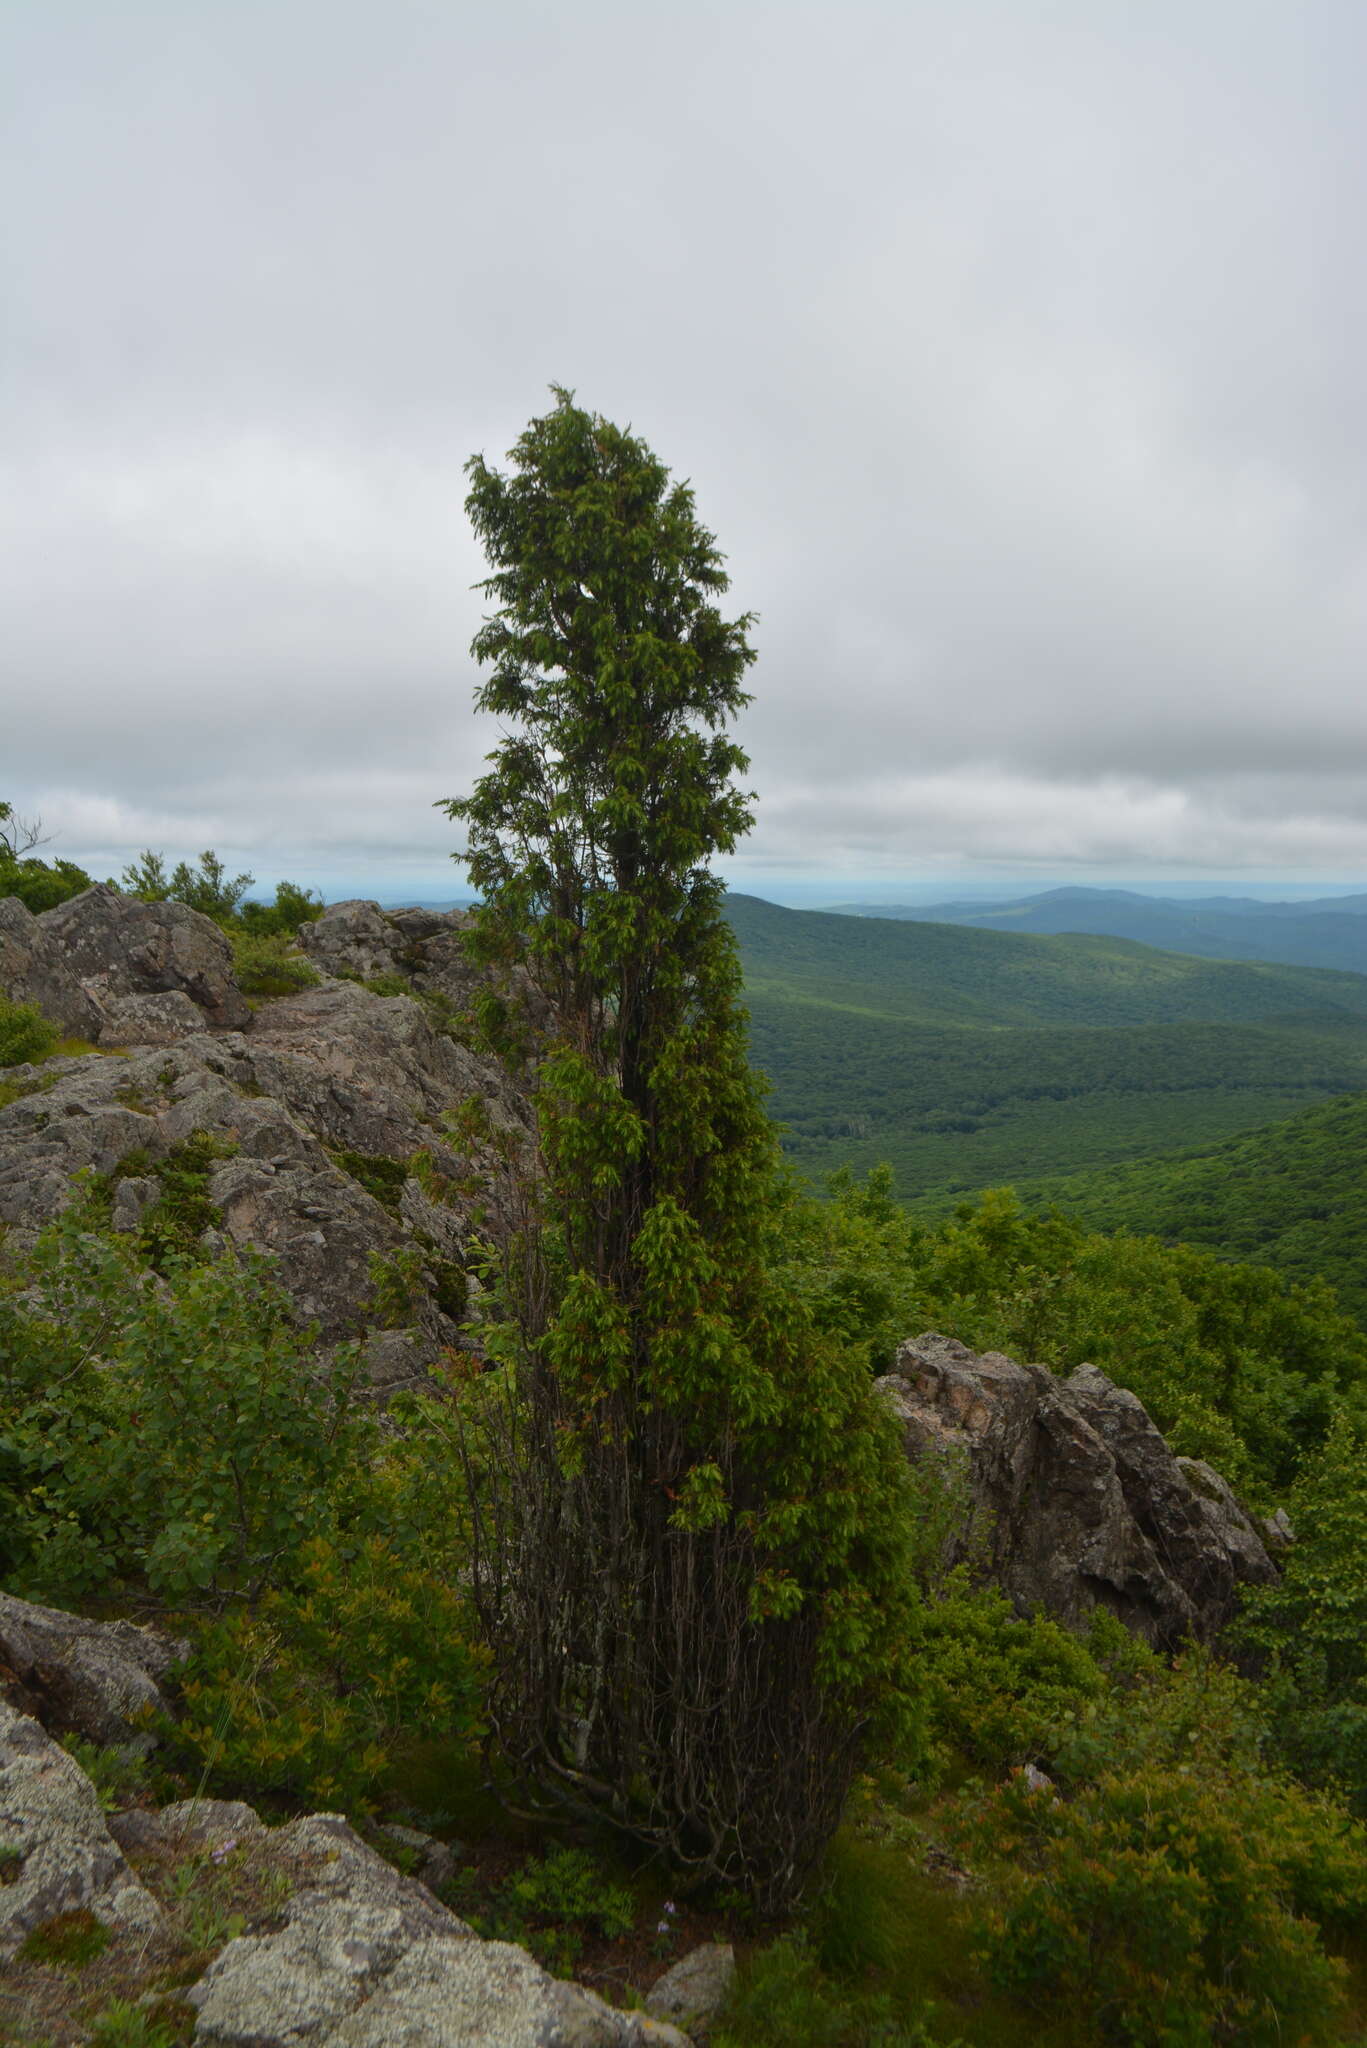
[879,1333,1277,1647]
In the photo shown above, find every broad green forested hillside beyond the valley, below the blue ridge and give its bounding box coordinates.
[730,897,1367,1210]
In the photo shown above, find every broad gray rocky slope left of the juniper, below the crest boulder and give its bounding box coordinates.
[0,970,531,1382]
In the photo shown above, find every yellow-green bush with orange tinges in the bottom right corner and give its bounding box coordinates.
[950,1659,1367,2048]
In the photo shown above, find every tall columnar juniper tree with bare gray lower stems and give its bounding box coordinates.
[445,389,912,1903]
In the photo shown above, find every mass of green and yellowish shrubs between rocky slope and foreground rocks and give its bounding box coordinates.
[0,1204,482,1804]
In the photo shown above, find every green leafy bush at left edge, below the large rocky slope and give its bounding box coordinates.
[0,1214,373,1606]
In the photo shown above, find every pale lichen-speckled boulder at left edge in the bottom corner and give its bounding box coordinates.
[0,1700,162,1962]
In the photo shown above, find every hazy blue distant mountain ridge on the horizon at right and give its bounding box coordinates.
[819,887,1367,975]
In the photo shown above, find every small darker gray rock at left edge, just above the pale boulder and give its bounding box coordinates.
[0,1593,184,1751]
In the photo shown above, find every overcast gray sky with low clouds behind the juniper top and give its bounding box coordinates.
[0,0,1367,899]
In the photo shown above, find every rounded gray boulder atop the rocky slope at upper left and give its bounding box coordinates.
[37,883,252,1030]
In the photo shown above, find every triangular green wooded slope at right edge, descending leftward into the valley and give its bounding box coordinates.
[1021,1096,1367,1323]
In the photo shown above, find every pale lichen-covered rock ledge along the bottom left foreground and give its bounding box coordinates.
[0,1704,691,2048]
